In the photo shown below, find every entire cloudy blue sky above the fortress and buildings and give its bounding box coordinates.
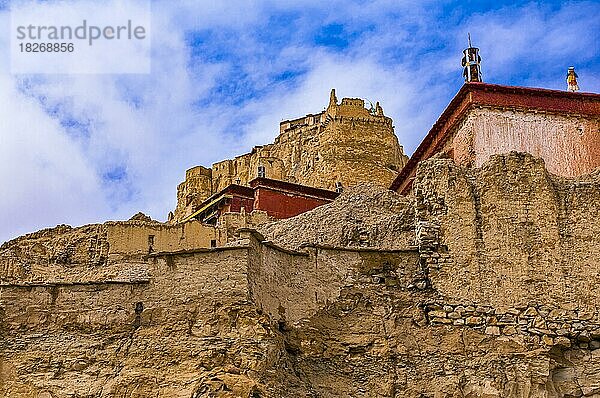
[0,0,600,241]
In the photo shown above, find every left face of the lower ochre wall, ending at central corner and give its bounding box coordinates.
[0,248,247,332]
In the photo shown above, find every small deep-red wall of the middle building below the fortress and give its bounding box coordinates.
[254,187,331,218]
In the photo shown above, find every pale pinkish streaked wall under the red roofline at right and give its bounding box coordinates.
[452,107,600,177]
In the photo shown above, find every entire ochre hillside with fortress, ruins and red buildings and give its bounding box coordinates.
[0,81,600,398]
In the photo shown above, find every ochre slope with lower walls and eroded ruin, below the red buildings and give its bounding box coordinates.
[0,153,600,398]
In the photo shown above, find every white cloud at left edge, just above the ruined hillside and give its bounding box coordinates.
[0,70,106,240]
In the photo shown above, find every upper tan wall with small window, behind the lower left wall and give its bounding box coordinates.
[0,216,271,283]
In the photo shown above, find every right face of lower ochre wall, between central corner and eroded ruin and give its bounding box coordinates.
[248,233,417,324]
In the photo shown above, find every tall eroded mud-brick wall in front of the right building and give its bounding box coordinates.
[415,152,600,346]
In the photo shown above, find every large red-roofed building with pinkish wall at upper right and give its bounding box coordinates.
[390,83,600,194]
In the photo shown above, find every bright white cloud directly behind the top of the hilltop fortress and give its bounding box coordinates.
[239,53,436,157]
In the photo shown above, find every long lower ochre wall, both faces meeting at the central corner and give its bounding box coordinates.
[0,225,418,332]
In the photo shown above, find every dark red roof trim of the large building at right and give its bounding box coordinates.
[390,82,600,194]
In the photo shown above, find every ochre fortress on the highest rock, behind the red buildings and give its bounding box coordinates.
[172,90,408,222]
